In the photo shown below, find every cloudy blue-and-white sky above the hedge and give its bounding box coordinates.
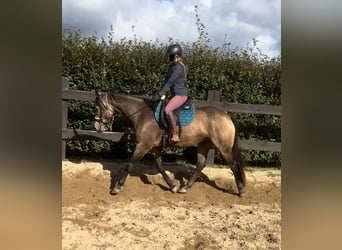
[62,0,281,57]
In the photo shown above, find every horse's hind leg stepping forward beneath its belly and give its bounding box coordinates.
[178,142,212,194]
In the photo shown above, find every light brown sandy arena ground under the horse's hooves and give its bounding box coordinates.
[62,161,281,250]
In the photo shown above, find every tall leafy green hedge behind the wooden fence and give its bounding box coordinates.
[62,23,281,166]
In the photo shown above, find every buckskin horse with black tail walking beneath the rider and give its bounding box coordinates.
[94,91,246,197]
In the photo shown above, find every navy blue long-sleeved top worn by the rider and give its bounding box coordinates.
[159,63,188,96]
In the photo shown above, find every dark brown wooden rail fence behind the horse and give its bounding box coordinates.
[62,78,281,162]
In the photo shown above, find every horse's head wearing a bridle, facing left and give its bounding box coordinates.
[94,91,114,132]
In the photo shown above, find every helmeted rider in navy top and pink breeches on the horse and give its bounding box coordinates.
[153,44,188,142]
